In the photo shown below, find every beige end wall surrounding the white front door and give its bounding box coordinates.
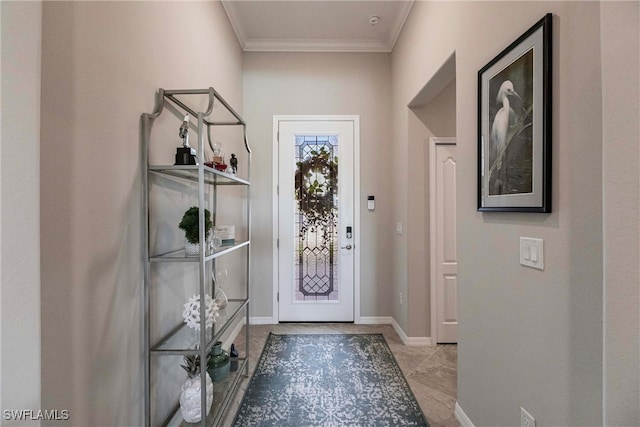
[243,52,394,320]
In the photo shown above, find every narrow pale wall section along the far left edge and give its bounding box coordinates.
[0,1,42,425]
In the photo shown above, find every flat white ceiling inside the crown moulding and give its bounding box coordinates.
[222,0,413,52]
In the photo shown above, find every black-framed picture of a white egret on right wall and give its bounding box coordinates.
[478,13,552,213]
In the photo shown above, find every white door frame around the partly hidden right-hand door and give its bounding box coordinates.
[429,137,457,345]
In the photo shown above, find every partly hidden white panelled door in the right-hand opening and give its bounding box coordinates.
[430,138,458,343]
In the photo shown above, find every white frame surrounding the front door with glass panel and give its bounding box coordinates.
[271,115,362,323]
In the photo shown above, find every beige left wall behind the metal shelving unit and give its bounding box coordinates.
[40,2,242,426]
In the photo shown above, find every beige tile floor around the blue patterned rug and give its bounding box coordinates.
[223,323,460,427]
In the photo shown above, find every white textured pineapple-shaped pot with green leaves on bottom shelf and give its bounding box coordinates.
[180,355,213,423]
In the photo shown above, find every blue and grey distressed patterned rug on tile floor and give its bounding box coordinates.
[233,334,429,427]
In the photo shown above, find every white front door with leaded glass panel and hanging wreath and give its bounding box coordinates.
[278,120,357,322]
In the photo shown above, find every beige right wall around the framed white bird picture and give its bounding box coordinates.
[392,2,638,425]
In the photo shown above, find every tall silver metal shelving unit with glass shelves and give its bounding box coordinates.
[141,88,251,427]
